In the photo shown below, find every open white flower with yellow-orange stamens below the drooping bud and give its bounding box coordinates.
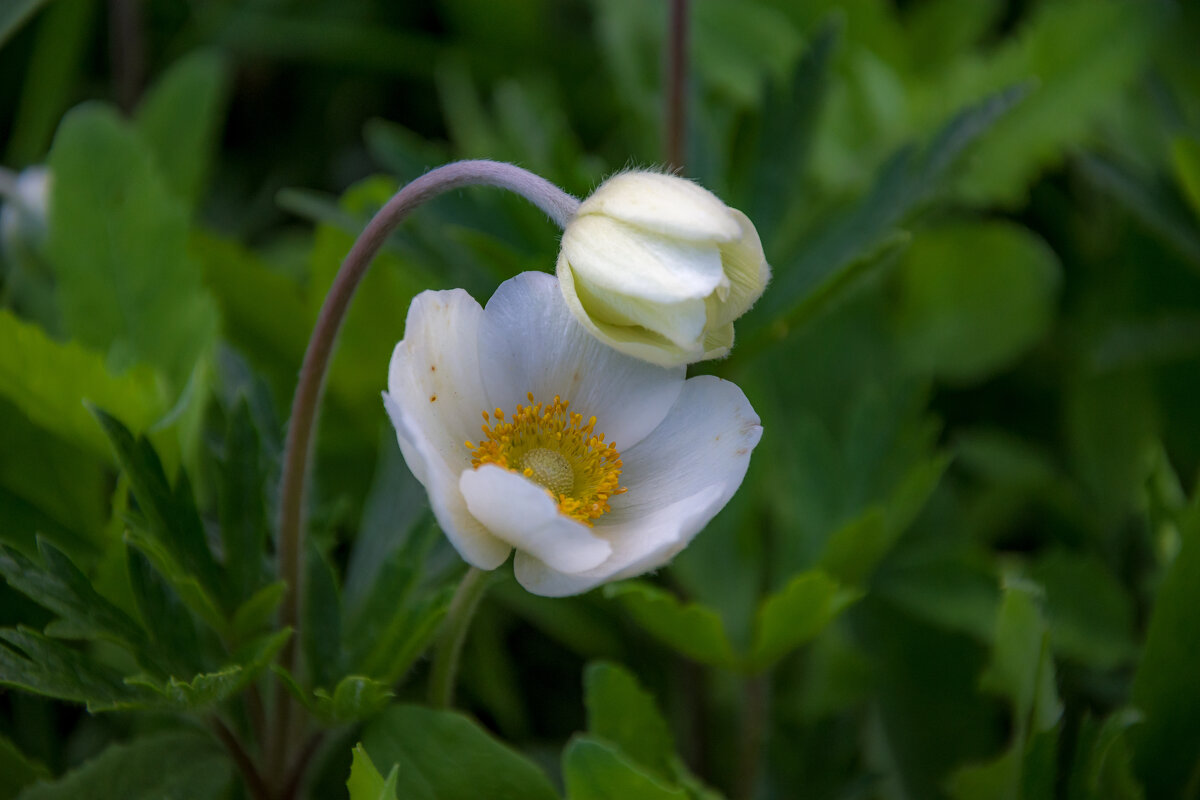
[384,272,762,596]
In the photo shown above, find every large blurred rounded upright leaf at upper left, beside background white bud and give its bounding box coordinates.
[47,106,217,393]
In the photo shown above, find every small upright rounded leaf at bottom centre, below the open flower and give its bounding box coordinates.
[583,662,676,778]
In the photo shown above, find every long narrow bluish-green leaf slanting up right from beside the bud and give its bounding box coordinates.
[739,86,1027,335]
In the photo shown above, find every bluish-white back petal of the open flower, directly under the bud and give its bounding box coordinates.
[475,272,684,449]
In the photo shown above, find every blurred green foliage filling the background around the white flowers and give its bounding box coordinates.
[0,0,1200,800]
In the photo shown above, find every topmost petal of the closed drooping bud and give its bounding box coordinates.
[578,172,738,241]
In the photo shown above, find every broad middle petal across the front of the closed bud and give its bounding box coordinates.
[562,215,727,302]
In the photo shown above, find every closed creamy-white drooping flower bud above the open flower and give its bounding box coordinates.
[558,172,770,366]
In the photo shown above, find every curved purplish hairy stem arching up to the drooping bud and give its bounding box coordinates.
[268,161,580,776]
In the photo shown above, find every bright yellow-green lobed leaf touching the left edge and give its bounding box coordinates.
[0,309,167,458]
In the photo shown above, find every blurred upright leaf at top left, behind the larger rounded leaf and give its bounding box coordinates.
[137,50,228,206]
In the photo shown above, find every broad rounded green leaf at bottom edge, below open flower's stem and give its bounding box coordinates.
[362,705,558,800]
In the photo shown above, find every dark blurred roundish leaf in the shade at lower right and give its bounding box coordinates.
[1030,551,1138,669]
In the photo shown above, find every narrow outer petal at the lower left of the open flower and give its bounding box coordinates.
[383,393,512,570]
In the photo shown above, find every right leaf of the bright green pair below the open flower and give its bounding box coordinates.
[750,571,860,670]
